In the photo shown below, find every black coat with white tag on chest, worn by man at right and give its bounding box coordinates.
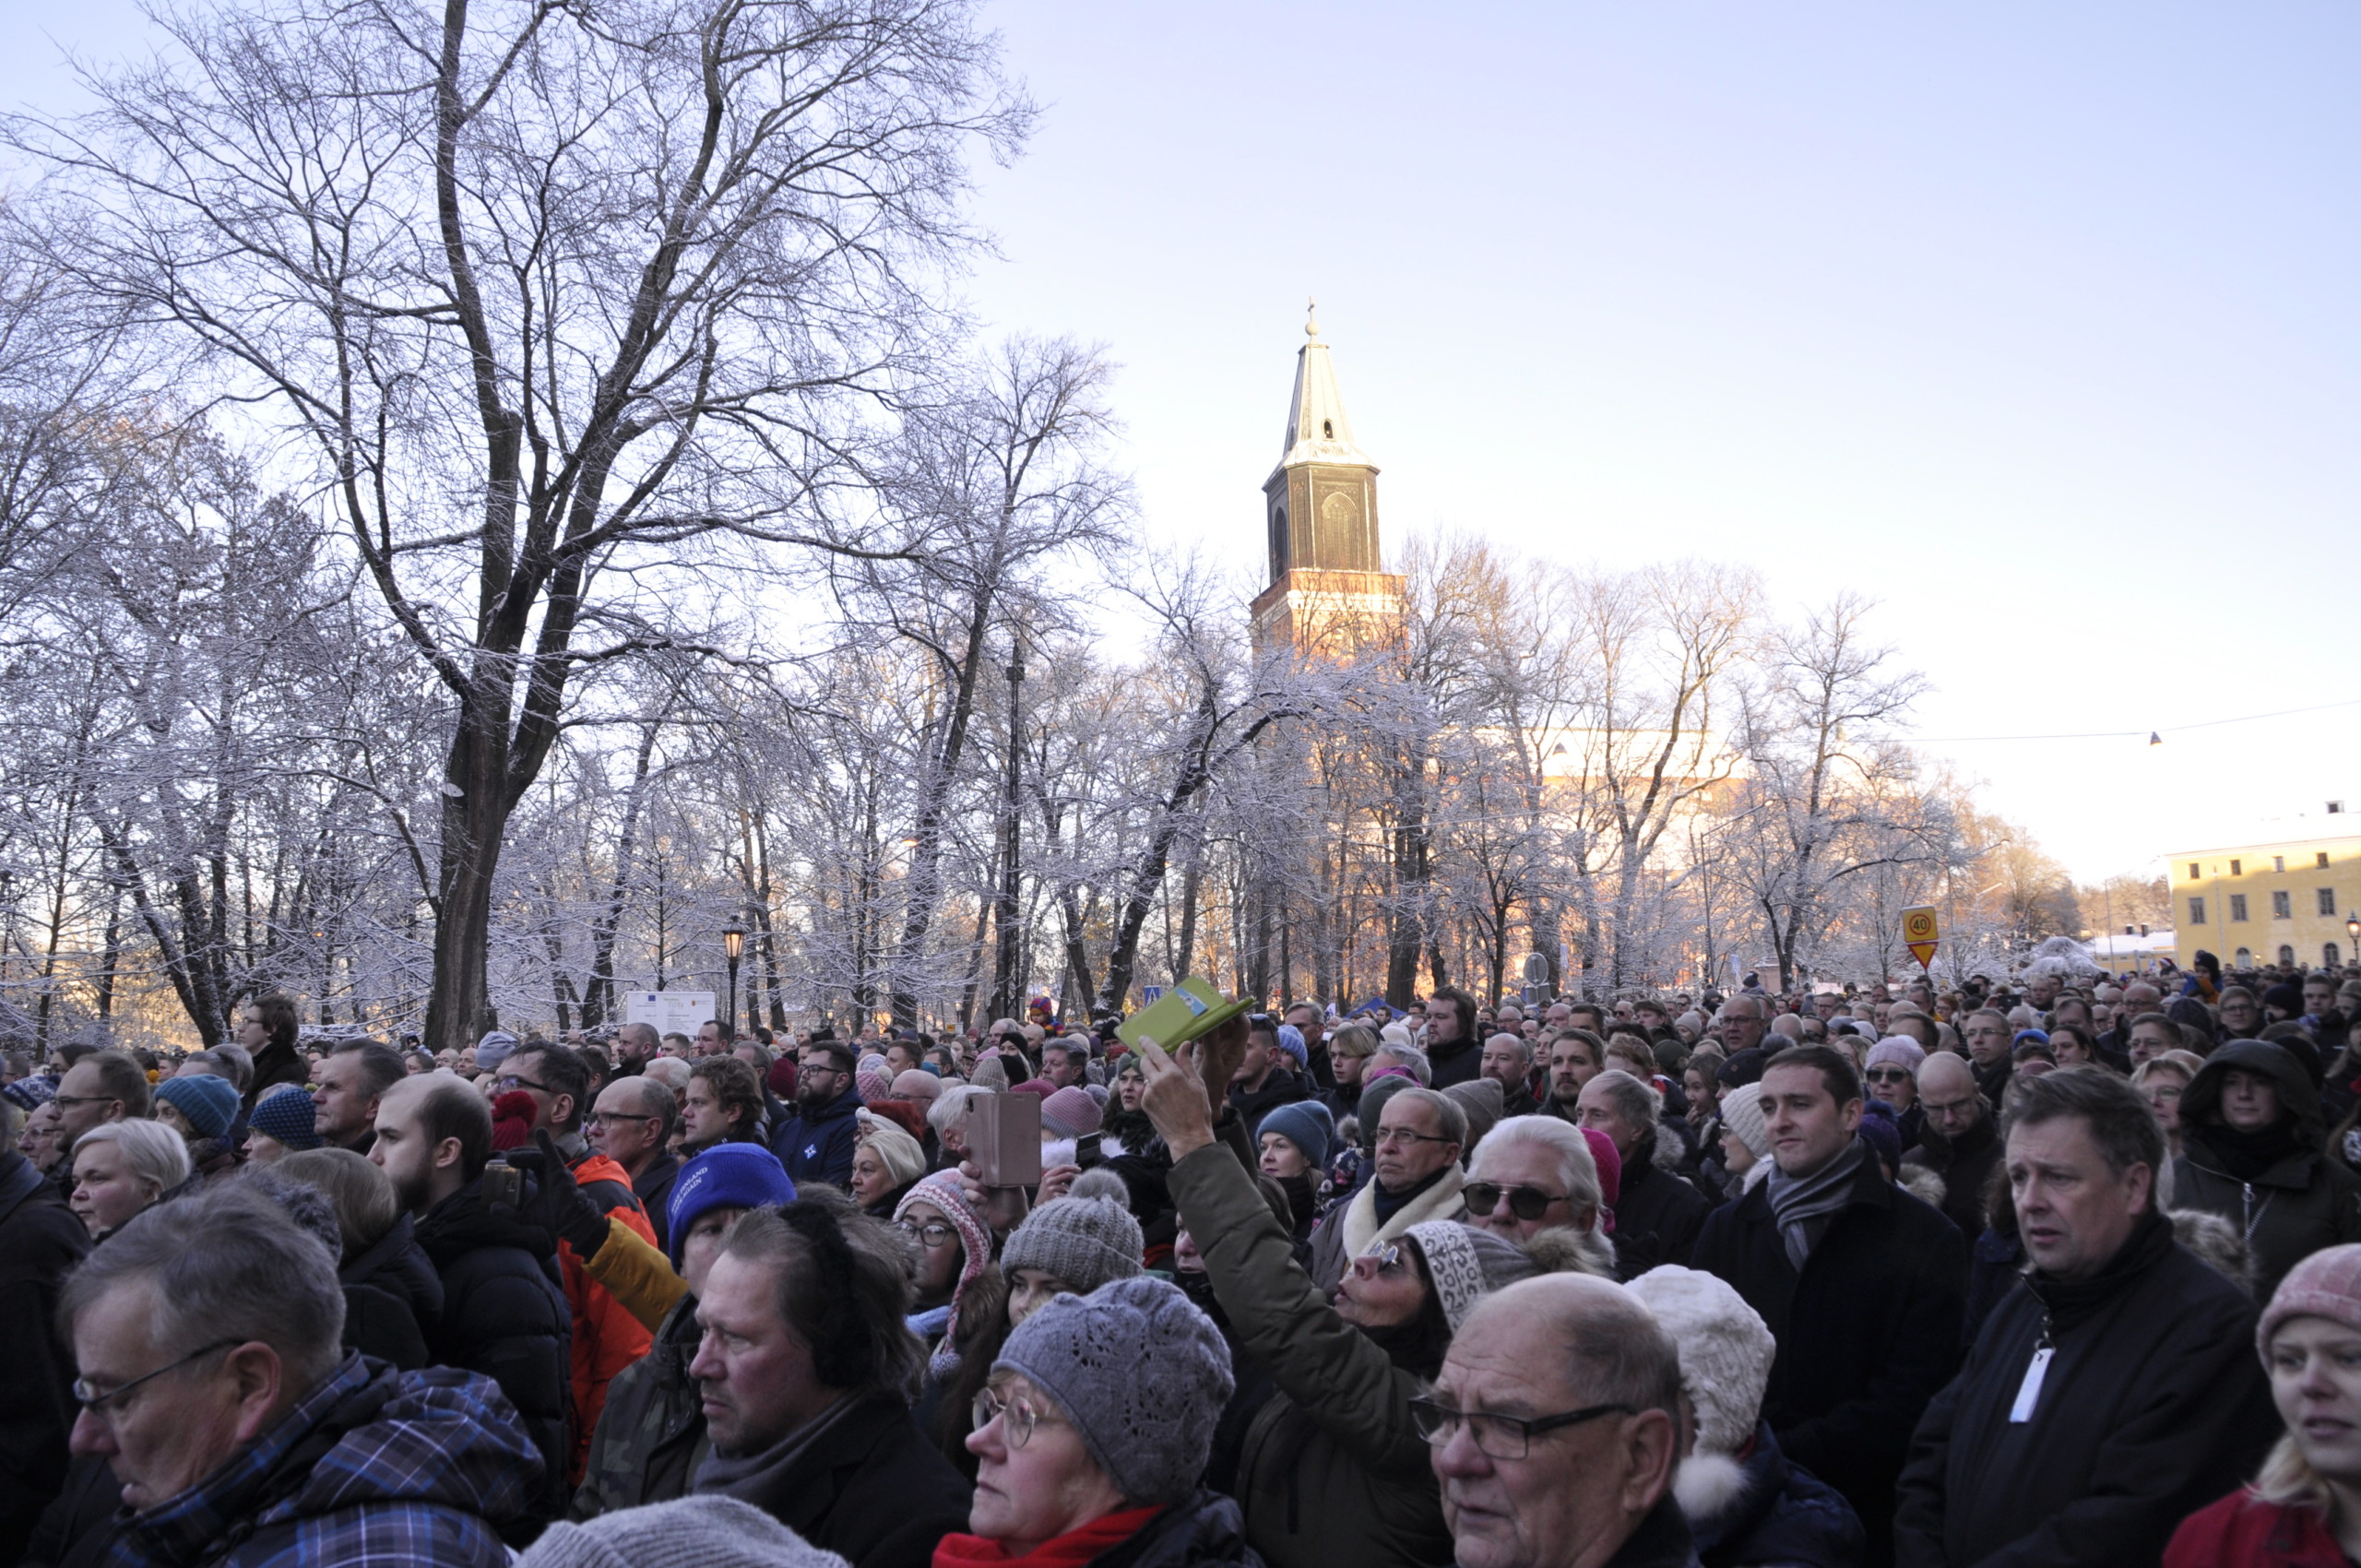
[1893,1214,2281,1568]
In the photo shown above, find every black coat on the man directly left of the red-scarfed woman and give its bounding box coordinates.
[696,1396,973,1568]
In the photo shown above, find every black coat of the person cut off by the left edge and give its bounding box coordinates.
[0,1150,89,1563]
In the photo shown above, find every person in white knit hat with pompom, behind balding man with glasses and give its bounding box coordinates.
[1629,1264,1868,1568]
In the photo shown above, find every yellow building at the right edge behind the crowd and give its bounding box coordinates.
[2167,822,2361,968]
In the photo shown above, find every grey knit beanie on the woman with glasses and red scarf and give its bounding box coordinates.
[991,1275,1237,1509]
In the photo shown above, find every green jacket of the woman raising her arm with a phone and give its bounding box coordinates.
[1169,1117,1452,1568]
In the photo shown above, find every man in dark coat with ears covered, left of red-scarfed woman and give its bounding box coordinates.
[690,1194,970,1568]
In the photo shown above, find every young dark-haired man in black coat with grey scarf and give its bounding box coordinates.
[1691,1046,1966,1563]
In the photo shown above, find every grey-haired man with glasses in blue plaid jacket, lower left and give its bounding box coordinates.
[62,1183,540,1568]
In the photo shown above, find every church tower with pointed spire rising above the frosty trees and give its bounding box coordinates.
[1253,315,1403,657]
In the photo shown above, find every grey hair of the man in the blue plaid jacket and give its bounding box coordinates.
[56,1183,345,1388]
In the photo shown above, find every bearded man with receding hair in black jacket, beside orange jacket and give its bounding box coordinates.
[368,1075,574,1521]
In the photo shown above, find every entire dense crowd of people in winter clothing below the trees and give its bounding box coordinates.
[14,954,2361,1568]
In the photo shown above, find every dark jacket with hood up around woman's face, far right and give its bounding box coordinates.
[2172,1039,2361,1301]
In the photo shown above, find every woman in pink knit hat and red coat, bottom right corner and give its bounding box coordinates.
[2165,1244,2361,1568]
